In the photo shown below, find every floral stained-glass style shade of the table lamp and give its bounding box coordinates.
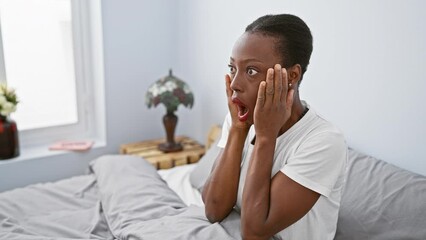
[145,70,194,113]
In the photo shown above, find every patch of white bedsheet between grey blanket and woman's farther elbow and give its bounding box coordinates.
[158,164,204,206]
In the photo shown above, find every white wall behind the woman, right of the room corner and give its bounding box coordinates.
[172,0,426,175]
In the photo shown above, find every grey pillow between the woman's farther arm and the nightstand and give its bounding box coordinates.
[189,134,221,192]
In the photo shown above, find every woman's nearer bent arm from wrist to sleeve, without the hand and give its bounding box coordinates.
[241,139,320,239]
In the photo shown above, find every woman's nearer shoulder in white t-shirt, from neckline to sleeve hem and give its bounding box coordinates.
[281,106,347,196]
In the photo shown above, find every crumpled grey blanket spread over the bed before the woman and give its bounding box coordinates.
[0,155,241,240]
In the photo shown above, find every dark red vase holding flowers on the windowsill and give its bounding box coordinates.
[0,115,19,160]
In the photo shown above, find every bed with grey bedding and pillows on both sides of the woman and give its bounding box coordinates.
[0,126,426,240]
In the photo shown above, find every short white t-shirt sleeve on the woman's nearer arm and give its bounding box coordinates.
[281,132,347,197]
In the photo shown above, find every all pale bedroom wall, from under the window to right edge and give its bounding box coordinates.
[0,0,426,191]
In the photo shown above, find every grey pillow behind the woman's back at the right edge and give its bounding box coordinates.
[334,149,426,240]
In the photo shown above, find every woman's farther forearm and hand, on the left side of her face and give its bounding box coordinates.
[202,75,250,223]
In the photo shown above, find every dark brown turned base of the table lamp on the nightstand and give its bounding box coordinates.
[158,111,183,153]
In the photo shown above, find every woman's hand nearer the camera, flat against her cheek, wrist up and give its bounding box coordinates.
[254,64,294,137]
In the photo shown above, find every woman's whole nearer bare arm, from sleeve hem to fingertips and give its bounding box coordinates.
[241,65,320,239]
